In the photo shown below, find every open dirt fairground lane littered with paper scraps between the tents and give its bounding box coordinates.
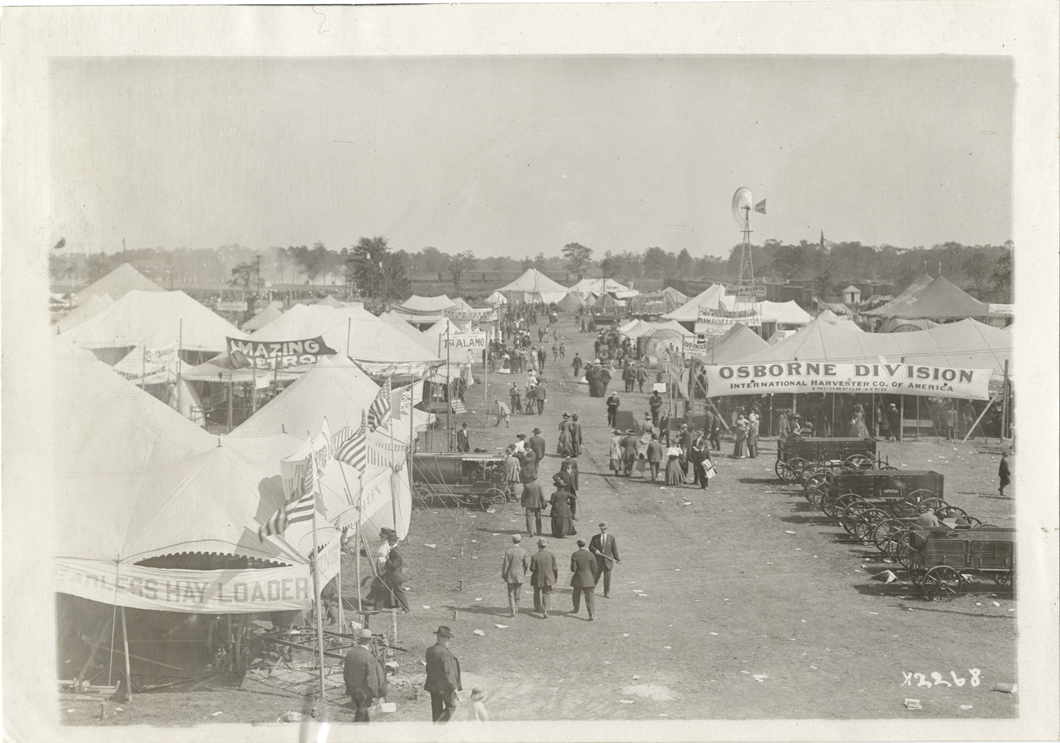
[61,317,1018,725]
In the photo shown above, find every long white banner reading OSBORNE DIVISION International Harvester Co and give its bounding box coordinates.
[704,361,991,400]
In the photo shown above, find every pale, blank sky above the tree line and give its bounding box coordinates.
[50,56,1014,258]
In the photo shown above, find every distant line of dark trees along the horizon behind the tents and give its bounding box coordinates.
[49,235,1013,302]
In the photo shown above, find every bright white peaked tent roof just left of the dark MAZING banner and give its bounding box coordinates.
[64,290,245,353]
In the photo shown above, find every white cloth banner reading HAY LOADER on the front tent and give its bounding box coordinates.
[54,555,326,614]
